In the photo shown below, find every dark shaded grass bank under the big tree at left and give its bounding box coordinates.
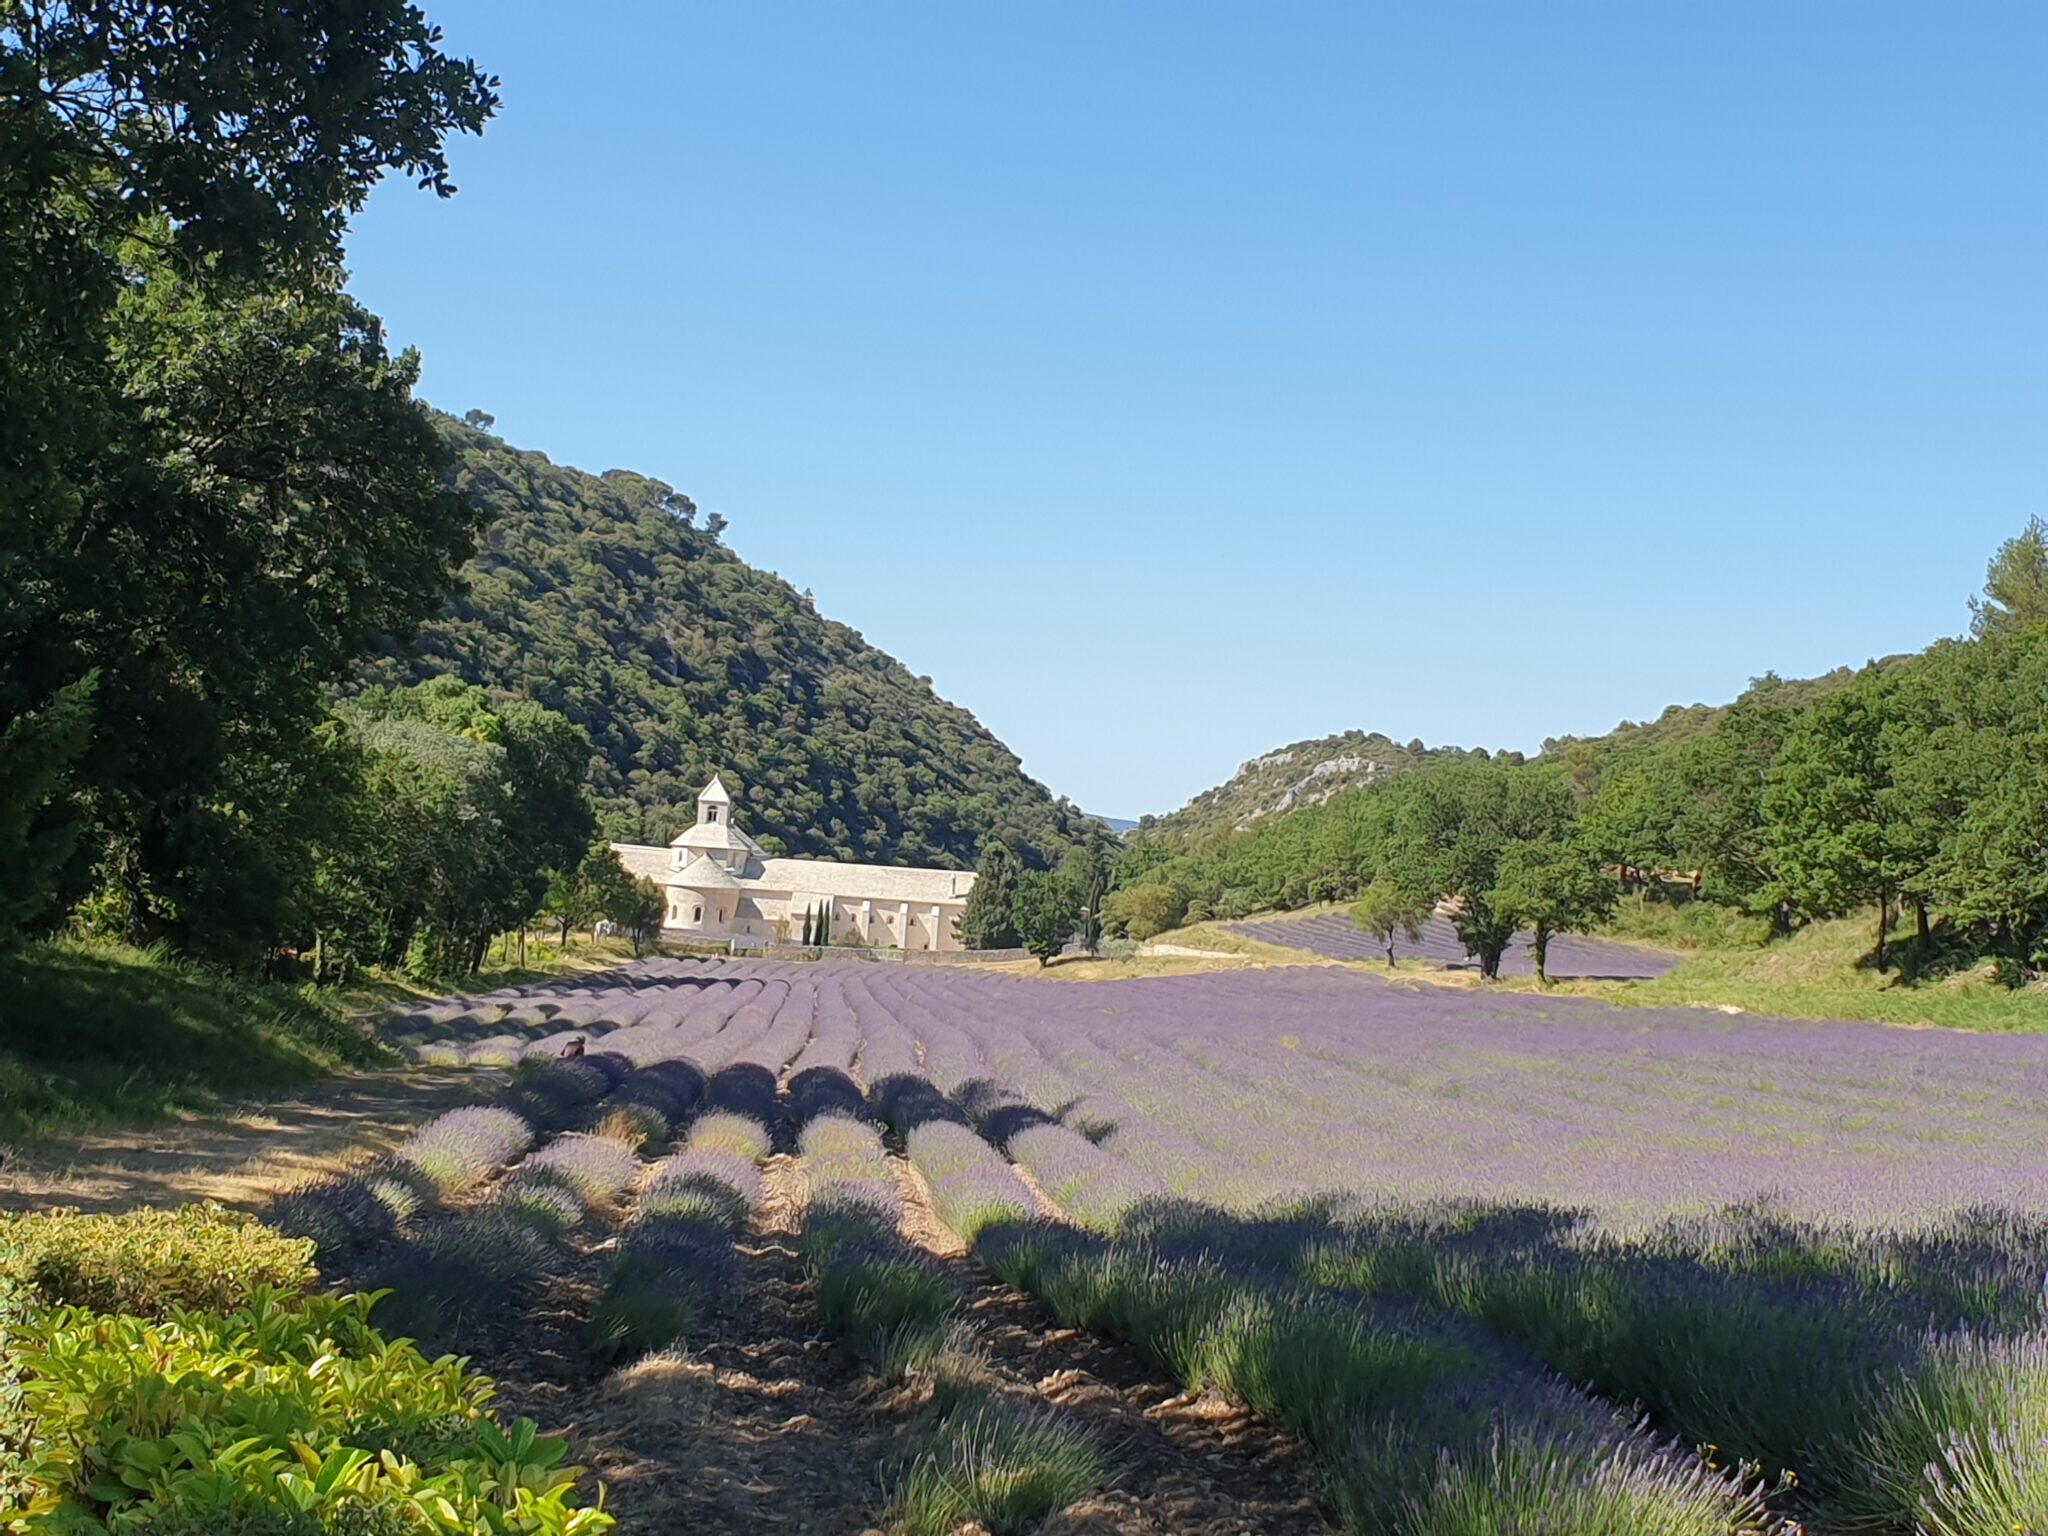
[0,940,391,1141]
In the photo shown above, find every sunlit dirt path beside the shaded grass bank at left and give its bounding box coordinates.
[0,1067,504,1210]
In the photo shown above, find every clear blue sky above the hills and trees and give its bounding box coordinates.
[350,0,2048,815]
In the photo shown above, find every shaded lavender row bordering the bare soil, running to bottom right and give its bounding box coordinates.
[979,1212,1780,1536]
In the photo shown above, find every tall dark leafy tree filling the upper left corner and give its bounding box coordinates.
[0,0,496,958]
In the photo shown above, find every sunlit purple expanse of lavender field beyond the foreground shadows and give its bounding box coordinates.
[393,961,2048,1225]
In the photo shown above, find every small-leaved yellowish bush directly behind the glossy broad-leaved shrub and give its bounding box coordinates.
[0,1204,313,1317]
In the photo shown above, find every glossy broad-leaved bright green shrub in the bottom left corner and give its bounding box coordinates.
[0,1286,612,1536]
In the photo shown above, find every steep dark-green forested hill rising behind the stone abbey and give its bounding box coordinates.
[365,418,1077,868]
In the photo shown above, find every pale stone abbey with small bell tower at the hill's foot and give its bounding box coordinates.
[612,778,975,950]
